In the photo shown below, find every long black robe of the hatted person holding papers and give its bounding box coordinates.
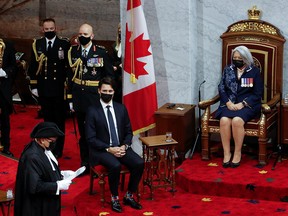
[14,141,61,216]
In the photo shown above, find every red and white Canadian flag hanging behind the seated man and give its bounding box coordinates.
[123,0,157,135]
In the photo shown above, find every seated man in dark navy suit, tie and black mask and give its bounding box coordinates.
[86,77,144,212]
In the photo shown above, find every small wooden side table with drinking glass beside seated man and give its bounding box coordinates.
[139,135,178,200]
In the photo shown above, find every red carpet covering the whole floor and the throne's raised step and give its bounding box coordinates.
[0,105,288,216]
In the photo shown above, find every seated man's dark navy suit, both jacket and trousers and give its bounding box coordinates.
[86,100,144,196]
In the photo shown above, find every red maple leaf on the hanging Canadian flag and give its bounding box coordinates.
[124,26,151,79]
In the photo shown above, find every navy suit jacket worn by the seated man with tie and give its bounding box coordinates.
[85,101,133,165]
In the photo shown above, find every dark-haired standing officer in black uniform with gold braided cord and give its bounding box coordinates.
[28,18,70,158]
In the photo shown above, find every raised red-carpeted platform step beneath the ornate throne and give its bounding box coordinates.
[176,154,288,201]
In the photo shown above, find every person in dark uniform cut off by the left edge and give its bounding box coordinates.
[0,38,17,157]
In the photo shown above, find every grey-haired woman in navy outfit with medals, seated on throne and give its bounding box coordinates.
[216,46,263,168]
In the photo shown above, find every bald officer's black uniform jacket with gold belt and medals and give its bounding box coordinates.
[68,44,114,112]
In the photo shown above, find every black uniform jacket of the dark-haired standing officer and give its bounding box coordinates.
[28,36,70,98]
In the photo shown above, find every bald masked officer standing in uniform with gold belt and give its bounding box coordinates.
[68,24,114,172]
